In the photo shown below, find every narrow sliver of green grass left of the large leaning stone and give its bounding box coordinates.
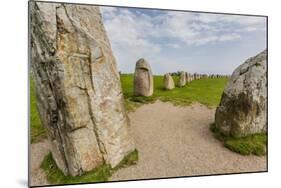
[30,77,47,143]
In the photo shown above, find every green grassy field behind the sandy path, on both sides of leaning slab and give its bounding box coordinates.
[30,74,228,143]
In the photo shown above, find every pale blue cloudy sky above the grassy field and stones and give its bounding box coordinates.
[101,7,266,74]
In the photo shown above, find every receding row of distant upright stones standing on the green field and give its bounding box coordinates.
[134,58,229,97]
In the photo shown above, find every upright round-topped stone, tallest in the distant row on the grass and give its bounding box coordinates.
[134,58,153,97]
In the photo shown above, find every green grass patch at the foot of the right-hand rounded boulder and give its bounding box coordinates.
[210,123,267,156]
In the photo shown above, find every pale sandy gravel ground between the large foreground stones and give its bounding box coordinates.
[31,101,266,185]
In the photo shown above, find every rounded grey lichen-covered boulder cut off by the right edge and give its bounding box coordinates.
[215,51,267,136]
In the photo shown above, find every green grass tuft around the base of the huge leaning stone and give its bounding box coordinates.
[41,150,138,184]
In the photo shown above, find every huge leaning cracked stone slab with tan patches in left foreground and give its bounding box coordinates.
[30,2,134,176]
